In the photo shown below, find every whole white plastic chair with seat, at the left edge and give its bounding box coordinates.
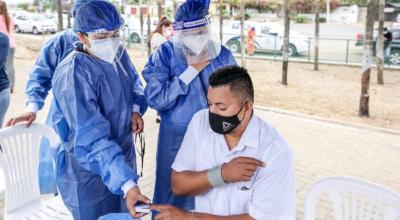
[0,124,73,220]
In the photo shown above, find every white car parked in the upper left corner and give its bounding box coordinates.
[14,14,57,34]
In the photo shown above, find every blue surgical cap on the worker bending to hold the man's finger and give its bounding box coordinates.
[72,1,124,32]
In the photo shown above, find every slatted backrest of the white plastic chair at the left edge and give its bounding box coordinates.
[0,124,59,212]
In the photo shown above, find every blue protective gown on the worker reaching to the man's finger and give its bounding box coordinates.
[52,46,147,220]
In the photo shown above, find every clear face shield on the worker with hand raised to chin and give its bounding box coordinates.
[172,16,221,65]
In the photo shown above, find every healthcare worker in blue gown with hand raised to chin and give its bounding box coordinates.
[143,0,236,213]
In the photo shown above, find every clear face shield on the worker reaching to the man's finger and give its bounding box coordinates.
[87,29,123,63]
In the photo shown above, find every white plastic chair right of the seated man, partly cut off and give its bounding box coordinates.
[304,177,400,220]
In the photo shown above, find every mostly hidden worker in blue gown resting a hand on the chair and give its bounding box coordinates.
[7,0,146,194]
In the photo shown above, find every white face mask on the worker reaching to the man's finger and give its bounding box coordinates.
[89,37,121,63]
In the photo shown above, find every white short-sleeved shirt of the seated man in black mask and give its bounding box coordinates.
[172,109,295,220]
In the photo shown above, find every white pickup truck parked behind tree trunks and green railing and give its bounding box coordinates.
[223,21,310,56]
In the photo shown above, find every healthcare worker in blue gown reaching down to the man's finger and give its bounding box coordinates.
[52,1,150,220]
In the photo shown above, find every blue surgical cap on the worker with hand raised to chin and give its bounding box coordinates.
[175,0,210,21]
